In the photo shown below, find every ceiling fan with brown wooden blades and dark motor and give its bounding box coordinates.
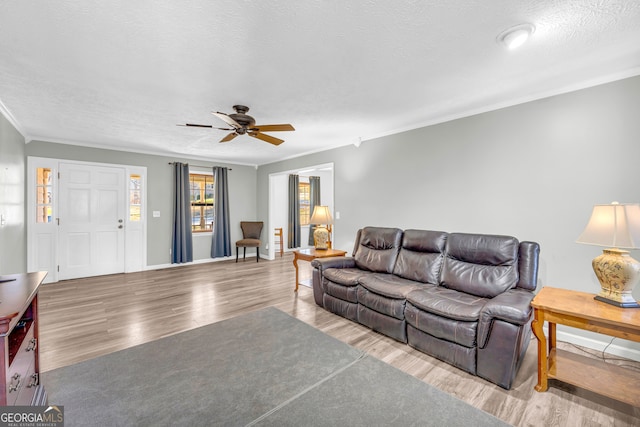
[179,105,295,145]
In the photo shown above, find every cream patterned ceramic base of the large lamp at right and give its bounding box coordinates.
[592,248,640,308]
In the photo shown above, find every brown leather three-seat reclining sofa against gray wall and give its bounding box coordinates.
[312,227,540,389]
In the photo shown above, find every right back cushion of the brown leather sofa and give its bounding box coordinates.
[440,233,519,298]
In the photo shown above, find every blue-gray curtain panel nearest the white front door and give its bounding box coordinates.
[171,162,193,264]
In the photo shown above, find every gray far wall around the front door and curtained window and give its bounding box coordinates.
[26,141,257,266]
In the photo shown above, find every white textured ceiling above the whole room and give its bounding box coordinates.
[0,0,640,165]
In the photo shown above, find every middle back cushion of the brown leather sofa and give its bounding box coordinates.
[393,230,447,284]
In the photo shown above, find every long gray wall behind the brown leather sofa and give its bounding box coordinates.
[258,77,640,358]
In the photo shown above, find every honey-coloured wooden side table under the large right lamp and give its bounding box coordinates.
[531,286,640,407]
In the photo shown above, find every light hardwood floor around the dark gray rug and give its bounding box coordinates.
[39,254,640,426]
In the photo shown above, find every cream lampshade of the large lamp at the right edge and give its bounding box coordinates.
[577,203,640,249]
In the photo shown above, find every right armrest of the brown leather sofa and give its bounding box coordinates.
[478,288,535,348]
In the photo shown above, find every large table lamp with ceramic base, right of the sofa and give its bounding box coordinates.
[577,202,640,308]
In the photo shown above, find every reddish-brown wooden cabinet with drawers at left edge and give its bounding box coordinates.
[0,272,47,406]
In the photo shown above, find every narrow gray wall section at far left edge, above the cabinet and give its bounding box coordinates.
[0,114,27,274]
